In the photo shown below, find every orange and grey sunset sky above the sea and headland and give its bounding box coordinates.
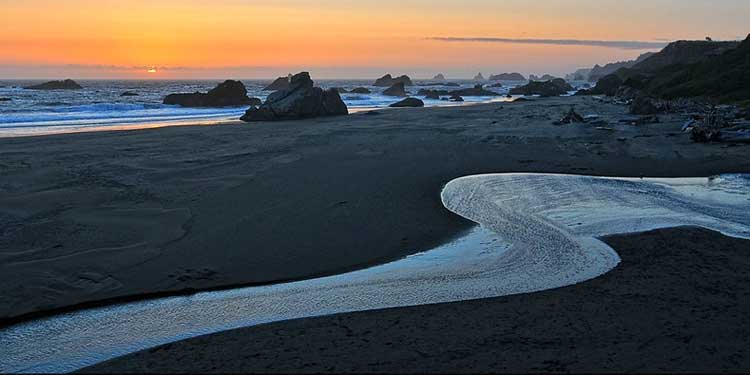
[0,0,750,79]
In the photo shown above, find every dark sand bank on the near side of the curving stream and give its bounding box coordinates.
[84,228,750,373]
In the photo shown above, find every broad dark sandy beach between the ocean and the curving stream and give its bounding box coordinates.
[0,98,750,323]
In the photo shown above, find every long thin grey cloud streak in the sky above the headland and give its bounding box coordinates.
[426,37,667,49]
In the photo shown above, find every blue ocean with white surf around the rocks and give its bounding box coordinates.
[0,80,548,137]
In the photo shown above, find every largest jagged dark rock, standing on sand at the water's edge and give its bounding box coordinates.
[241,72,349,122]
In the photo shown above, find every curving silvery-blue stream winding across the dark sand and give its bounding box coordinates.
[0,174,750,373]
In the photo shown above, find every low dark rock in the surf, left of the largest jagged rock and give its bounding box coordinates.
[164,80,252,107]
